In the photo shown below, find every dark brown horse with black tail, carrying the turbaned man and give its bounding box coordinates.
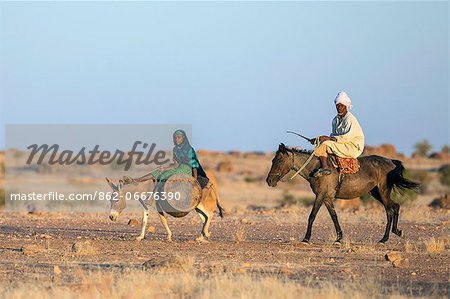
[266,143,419,243]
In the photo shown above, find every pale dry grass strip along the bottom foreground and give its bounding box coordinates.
[0,270,408,299]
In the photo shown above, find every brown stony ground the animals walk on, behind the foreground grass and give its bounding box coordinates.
[0,206,450,297]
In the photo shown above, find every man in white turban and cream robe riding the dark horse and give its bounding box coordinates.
[311,91,364,177]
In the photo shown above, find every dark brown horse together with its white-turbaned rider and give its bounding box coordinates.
[266,92,420,243]
